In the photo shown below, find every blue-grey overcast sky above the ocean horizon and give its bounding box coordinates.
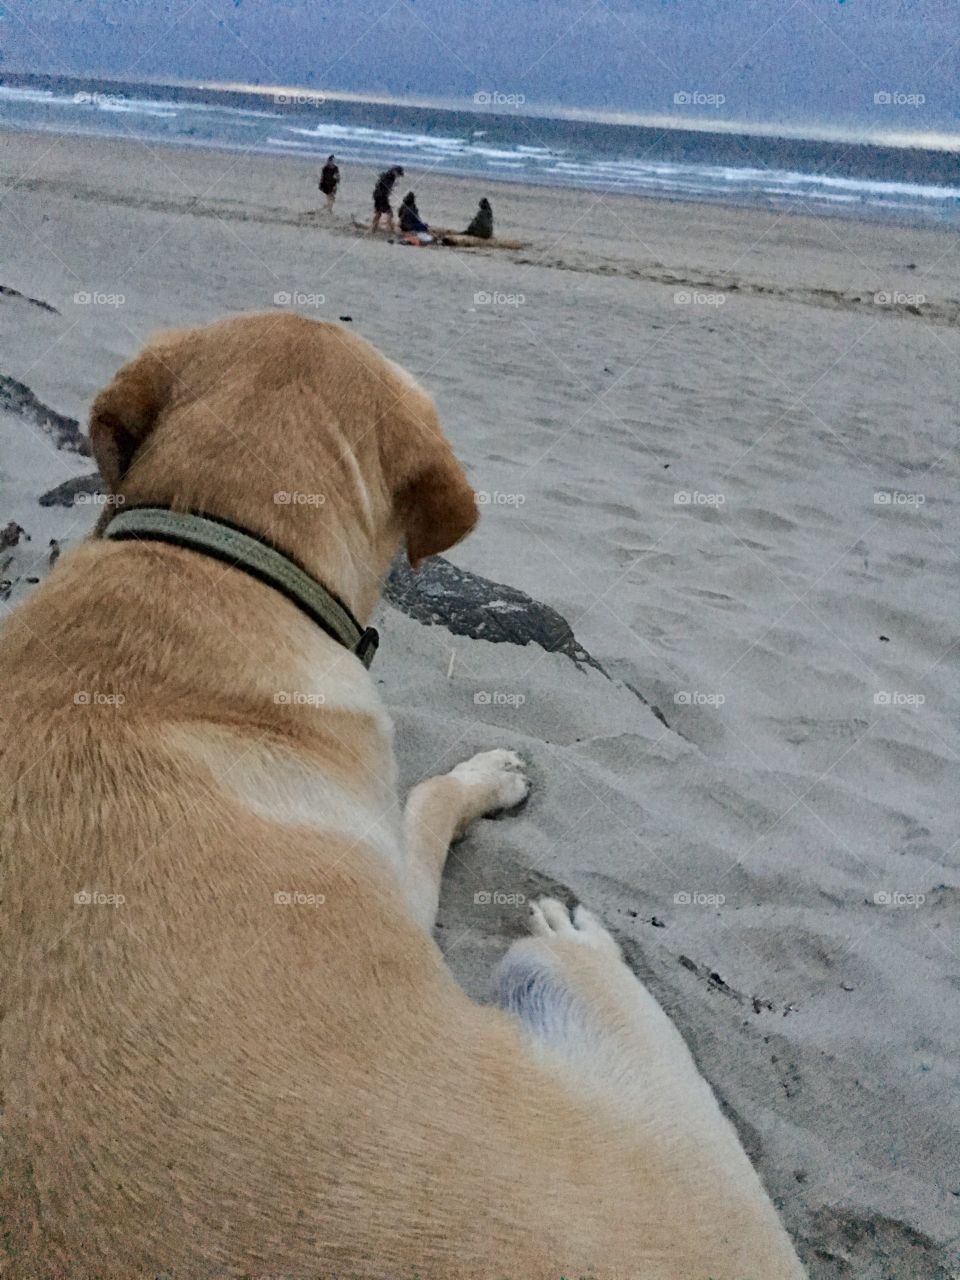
[0,0,960,131]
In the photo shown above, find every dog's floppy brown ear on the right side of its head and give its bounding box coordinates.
[398,436,479,568]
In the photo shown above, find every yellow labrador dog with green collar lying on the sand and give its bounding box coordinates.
[0,315,803,1280]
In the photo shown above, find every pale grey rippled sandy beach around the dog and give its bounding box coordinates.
[0,133,960,1280]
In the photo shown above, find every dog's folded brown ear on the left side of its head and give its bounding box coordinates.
[90,347,173,493]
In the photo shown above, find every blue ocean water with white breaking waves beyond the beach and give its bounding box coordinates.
[0,74,960,224]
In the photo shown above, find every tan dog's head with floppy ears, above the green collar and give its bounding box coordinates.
[90,312,477,613]
